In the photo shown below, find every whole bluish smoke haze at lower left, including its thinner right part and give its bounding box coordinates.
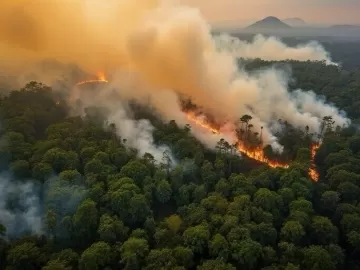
[0,172,86,238]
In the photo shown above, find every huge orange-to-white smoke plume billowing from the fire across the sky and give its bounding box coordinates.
[0,0,350,151]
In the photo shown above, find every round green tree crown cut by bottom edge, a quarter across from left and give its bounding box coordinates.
[79,242,111,270]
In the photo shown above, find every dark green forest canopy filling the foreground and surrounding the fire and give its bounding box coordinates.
[0,61,360,270]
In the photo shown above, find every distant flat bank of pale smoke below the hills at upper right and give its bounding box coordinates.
[215,34,336,65]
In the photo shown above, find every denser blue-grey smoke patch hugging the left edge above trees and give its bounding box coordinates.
[0,173,43,237]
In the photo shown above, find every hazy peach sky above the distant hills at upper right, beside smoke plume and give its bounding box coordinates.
[179,0,360,24]
